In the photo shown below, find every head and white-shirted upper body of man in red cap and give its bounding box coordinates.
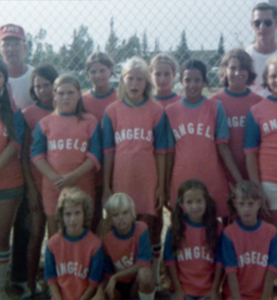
[0,24,34,108]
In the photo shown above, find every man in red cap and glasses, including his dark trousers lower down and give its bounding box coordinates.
[0,24,34,296]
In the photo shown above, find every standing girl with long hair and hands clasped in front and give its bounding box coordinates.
[32,75,101,236]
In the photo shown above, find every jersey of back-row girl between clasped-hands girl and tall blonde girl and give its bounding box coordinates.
[82,88,117,186]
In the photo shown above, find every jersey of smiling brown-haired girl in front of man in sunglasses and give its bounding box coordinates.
[211,88,263,184]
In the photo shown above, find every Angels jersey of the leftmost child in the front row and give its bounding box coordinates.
[44,229,104,300]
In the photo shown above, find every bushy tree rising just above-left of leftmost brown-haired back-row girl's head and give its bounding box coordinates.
[67,25,93,71]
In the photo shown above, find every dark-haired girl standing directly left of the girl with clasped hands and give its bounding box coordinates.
[21,63,59,299]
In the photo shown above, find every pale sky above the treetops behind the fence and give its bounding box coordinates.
[0,0,268,51]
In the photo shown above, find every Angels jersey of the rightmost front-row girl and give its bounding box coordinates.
[222,220,277,300]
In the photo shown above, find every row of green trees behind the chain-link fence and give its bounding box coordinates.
[25,18,222,88]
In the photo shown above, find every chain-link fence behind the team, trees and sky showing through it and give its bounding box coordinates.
[1,0,275,88]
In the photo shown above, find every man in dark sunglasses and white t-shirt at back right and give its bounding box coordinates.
[245,3,277,97]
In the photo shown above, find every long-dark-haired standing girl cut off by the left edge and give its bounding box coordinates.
[0,61,24,300]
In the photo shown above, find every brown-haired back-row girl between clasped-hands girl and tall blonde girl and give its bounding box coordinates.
[82,52,116,232]
